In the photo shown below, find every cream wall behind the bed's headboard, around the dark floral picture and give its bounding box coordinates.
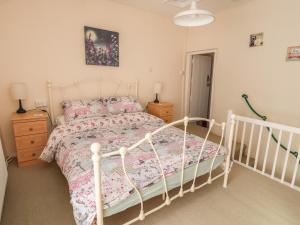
[0,0,186,155]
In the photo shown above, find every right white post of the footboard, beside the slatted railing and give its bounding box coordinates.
[223,110,235,188]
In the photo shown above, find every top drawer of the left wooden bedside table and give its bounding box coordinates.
[14,120,48,137]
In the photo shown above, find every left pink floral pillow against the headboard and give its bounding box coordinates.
[62,98,108,122]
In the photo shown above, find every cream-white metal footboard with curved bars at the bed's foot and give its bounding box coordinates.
[91,112,234,225]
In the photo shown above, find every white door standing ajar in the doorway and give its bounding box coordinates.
[189,55,212,118]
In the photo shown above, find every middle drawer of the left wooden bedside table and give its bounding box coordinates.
[16,133,48,150]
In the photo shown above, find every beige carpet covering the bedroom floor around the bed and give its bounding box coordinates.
[0,126,300,225]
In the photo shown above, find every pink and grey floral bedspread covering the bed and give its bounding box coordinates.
[40,112,225,225]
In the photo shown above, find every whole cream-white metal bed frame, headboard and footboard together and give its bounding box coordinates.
[47,78,234,225]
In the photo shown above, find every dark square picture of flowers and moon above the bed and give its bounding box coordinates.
[84,26,119,67]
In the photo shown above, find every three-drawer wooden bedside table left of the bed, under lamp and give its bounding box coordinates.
[11,111,48,166]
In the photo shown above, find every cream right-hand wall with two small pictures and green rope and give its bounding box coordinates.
[187,0,300,181]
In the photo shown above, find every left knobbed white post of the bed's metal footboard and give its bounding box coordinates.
[91,143,104,225]
